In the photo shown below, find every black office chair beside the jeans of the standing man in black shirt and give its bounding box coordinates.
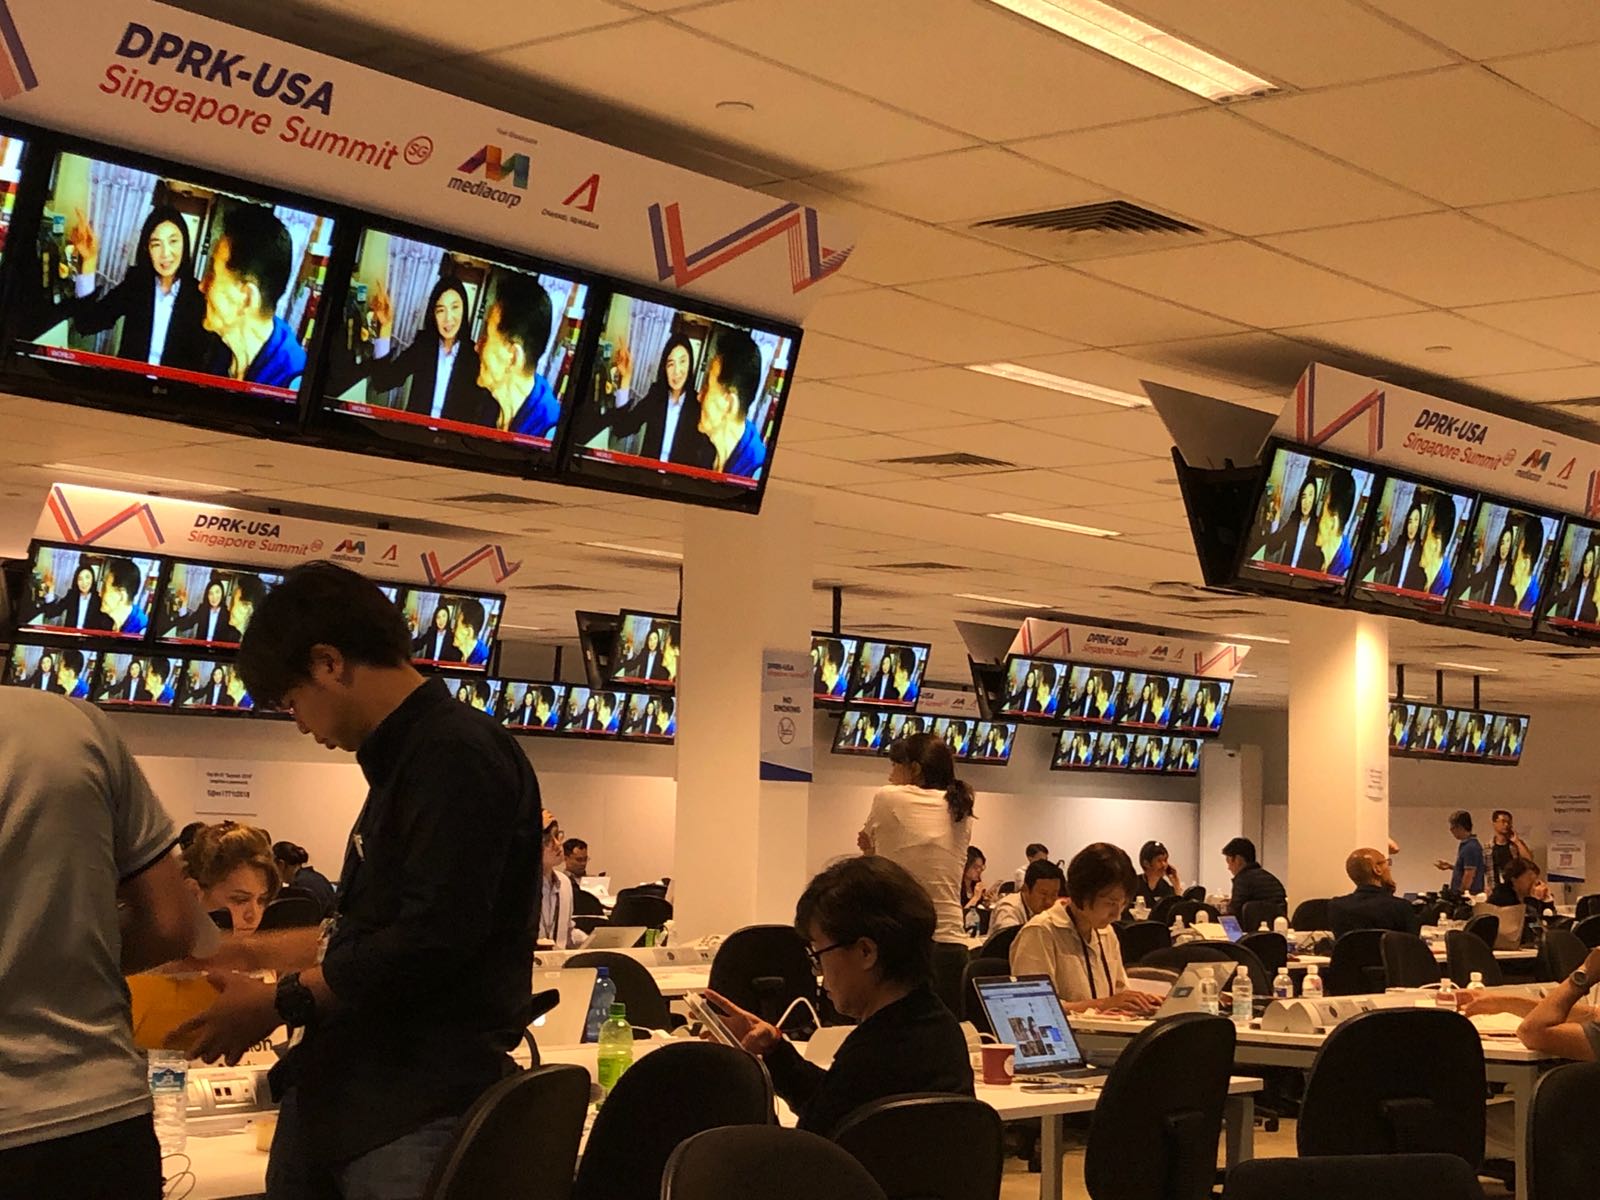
[424,1066,589,1200]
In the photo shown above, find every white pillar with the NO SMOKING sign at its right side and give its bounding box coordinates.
[672,483,814,941]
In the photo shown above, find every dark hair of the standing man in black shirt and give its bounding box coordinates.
[238,562,411,706]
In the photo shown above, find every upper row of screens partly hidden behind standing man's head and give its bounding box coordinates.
[14,541,506,674]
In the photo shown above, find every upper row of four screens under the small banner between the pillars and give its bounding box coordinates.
[998,654,1234,738]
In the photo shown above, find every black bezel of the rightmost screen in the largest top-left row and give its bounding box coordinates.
[557,278,803,512]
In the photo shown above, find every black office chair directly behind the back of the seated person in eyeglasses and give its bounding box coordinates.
[832,1096,1005,1200]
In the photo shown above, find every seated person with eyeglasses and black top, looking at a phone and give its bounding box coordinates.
[706,854,973,1136]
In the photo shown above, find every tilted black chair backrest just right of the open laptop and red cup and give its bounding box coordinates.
[1083,1013,1234,1200]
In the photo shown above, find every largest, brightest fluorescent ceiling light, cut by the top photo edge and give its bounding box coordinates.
[990,0,1278,101]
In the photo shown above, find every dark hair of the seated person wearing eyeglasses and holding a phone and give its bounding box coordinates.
[795,854,936,984]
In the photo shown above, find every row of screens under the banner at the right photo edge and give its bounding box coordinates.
[1190,442,1600,640]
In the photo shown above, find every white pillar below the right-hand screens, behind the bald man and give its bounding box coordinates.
[1286,605,1389,906]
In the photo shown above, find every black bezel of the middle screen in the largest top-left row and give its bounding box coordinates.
[302,210,606,480]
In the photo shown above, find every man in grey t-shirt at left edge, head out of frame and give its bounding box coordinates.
[0,688,197,1200]
